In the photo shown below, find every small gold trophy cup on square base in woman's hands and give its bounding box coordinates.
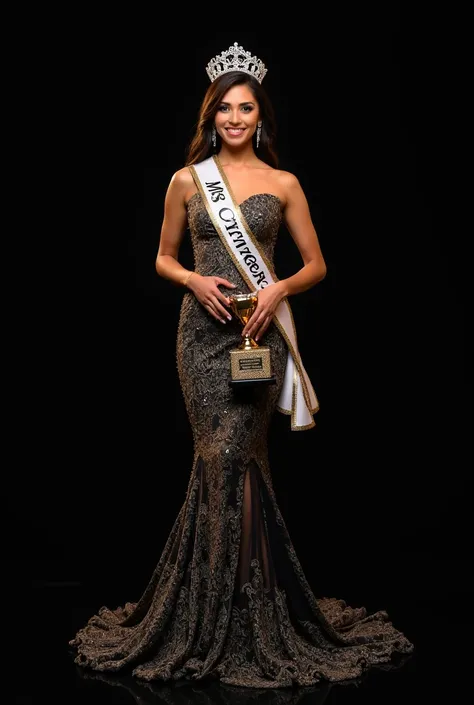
[228,292,276,385]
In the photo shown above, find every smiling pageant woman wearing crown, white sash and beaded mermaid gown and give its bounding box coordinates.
[70,45,413,688]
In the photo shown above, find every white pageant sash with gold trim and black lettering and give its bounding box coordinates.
[189,156,319,431]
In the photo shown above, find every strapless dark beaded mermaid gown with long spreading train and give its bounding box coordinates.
[70,193,413,688]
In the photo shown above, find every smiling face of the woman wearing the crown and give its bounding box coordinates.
[214,84,260,147]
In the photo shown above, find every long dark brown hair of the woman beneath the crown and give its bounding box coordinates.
[186,71,278,169]
